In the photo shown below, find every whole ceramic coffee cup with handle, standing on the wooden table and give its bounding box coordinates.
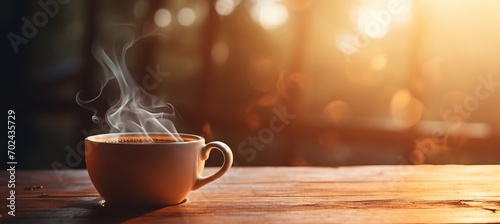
[85,133,233,207]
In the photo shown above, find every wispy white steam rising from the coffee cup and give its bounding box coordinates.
[76,26,181,141]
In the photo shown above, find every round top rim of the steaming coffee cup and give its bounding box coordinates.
[85,132,205,145]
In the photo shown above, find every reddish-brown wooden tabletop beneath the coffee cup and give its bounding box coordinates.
[0,165,500,223]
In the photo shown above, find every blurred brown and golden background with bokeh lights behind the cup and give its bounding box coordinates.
[0,0,500,169]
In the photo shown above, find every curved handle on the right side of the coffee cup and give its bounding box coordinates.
[193,141,233,190]
